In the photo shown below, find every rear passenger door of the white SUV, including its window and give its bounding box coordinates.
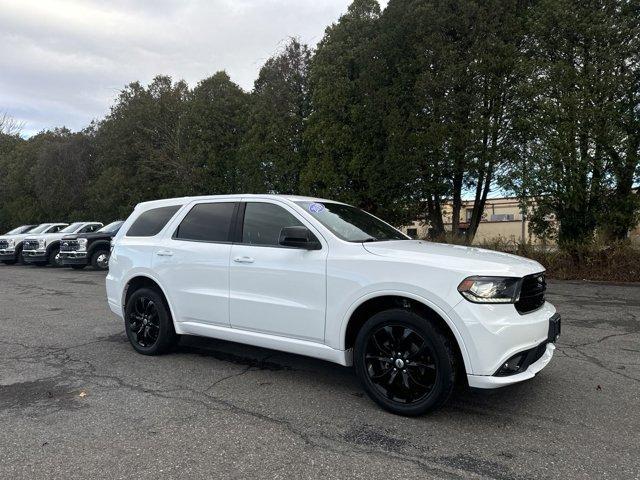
[153,200,238,326]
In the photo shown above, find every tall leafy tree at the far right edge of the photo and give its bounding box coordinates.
[523,0,639,246]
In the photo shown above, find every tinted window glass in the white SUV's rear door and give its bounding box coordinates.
[173,202,236,242]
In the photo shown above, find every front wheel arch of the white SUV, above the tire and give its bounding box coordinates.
[341,292,472,372]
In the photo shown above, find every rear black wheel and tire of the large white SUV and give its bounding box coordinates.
[124,288,178,355]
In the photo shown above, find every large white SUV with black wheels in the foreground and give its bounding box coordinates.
[106,195,560,415]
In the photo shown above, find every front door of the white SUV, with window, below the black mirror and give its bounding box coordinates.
[229,200,327,342]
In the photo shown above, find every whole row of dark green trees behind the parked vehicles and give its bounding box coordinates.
[0,0,640,248]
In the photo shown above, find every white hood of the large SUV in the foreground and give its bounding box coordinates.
[362,240,544,277]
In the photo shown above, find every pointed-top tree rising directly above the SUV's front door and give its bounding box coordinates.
[242,39,311,193]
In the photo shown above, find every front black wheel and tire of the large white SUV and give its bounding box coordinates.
[354,309,456,416]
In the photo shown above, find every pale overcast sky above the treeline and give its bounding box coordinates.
[0,0,387,136]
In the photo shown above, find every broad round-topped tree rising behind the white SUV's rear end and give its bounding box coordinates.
[91,76,188,218]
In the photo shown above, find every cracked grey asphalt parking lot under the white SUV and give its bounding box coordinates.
[0,265,640,480]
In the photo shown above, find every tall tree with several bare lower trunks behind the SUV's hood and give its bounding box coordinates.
[380,0,526,242]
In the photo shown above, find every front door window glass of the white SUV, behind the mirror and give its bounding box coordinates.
[242,202,302,245]
